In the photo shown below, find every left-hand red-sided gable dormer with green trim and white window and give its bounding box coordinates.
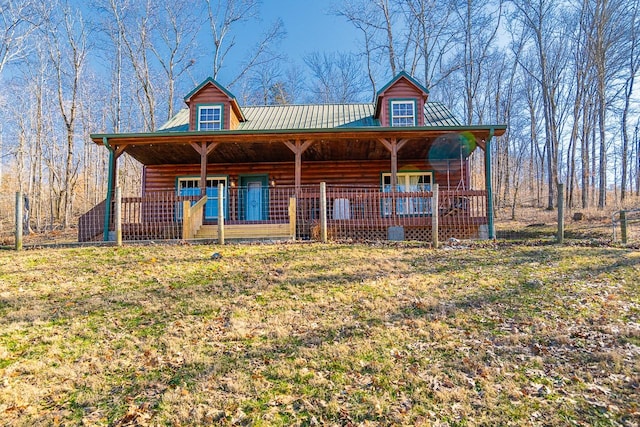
[184,77,246,131]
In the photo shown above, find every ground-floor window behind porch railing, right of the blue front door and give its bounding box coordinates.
[382,172,432,216]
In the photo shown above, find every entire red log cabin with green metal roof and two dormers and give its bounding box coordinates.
[84,72,506,241]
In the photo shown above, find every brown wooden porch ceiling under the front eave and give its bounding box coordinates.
[91,127,505,165]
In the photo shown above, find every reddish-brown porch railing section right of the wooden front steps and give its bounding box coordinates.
[298,186,487,240]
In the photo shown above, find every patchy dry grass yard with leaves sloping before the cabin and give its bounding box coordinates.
[0,244,640,426]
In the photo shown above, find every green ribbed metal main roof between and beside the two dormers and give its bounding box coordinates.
[158,102,461,132]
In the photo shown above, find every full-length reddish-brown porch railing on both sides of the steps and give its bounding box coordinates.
[79,185,487,241]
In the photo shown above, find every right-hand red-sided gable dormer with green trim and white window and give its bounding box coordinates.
[375,71,429,127]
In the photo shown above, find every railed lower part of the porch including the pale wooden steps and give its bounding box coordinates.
[78,185,488,242]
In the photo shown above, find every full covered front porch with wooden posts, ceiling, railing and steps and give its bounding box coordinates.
[84,126,504,241]
